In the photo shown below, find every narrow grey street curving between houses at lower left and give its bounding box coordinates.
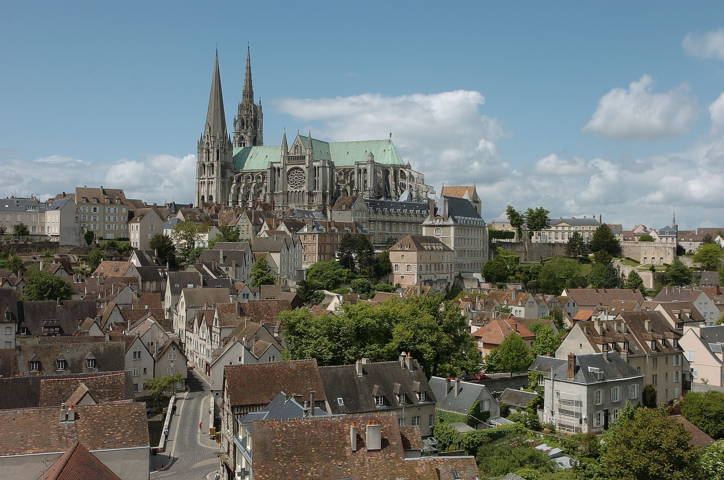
[151,370,219,480]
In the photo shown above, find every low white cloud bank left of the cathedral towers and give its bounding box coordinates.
[0,155,196,203]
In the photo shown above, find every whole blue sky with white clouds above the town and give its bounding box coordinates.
[0,0,724,228]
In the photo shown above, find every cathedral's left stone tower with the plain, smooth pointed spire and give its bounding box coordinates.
[194,51,232,207]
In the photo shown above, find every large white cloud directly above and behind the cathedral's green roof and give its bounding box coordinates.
[276,90,507,184]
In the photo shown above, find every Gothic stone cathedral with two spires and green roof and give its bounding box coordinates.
[194,49,432,211]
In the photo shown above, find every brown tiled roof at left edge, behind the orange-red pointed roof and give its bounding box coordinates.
[0,400,149,455]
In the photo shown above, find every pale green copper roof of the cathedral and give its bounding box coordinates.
[234,135,406,170]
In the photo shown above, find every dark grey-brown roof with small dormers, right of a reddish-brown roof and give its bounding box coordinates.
[319,359,435,414]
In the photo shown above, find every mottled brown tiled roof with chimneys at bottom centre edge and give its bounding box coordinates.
[254,415,479,480]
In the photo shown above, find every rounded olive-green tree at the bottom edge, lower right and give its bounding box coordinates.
[600,408,698,480]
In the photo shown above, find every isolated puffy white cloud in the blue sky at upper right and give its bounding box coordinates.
[583,75,696,140]
